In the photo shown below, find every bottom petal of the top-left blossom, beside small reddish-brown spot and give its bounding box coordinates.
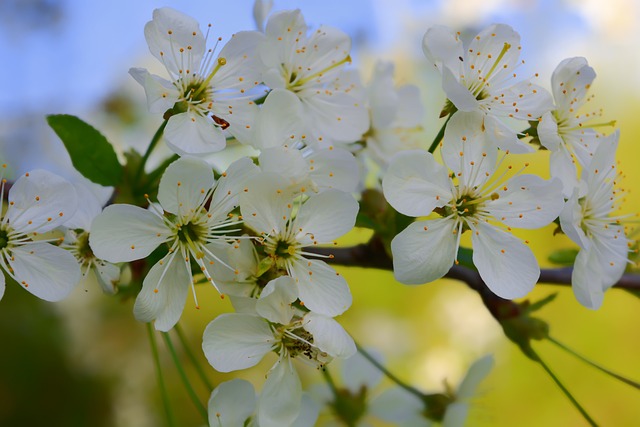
[164,111,227,156]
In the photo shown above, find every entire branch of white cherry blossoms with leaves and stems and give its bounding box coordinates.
[0,1,640,427]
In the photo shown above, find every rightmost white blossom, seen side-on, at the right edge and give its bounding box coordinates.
[560,132,629,309]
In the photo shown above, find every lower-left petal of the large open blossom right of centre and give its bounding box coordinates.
[391,219,456,285]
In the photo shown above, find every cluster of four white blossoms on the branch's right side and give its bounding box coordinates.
[383,25,630,308]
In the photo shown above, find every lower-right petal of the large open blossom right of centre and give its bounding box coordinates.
[472,222,540,299]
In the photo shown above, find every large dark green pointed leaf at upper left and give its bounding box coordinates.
[47,114,122,186]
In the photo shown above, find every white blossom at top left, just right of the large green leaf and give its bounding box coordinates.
[129,7,262,155]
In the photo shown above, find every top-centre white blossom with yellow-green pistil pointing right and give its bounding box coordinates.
[258,10,369,145]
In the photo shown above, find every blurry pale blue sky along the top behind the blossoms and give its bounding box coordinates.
[0,0,624,121]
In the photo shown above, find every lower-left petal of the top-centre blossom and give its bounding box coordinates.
[253,89,304,149]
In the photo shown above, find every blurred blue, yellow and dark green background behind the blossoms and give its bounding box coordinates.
[0,0,640,427]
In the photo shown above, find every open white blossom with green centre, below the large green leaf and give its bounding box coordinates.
[89,157,257,331]
